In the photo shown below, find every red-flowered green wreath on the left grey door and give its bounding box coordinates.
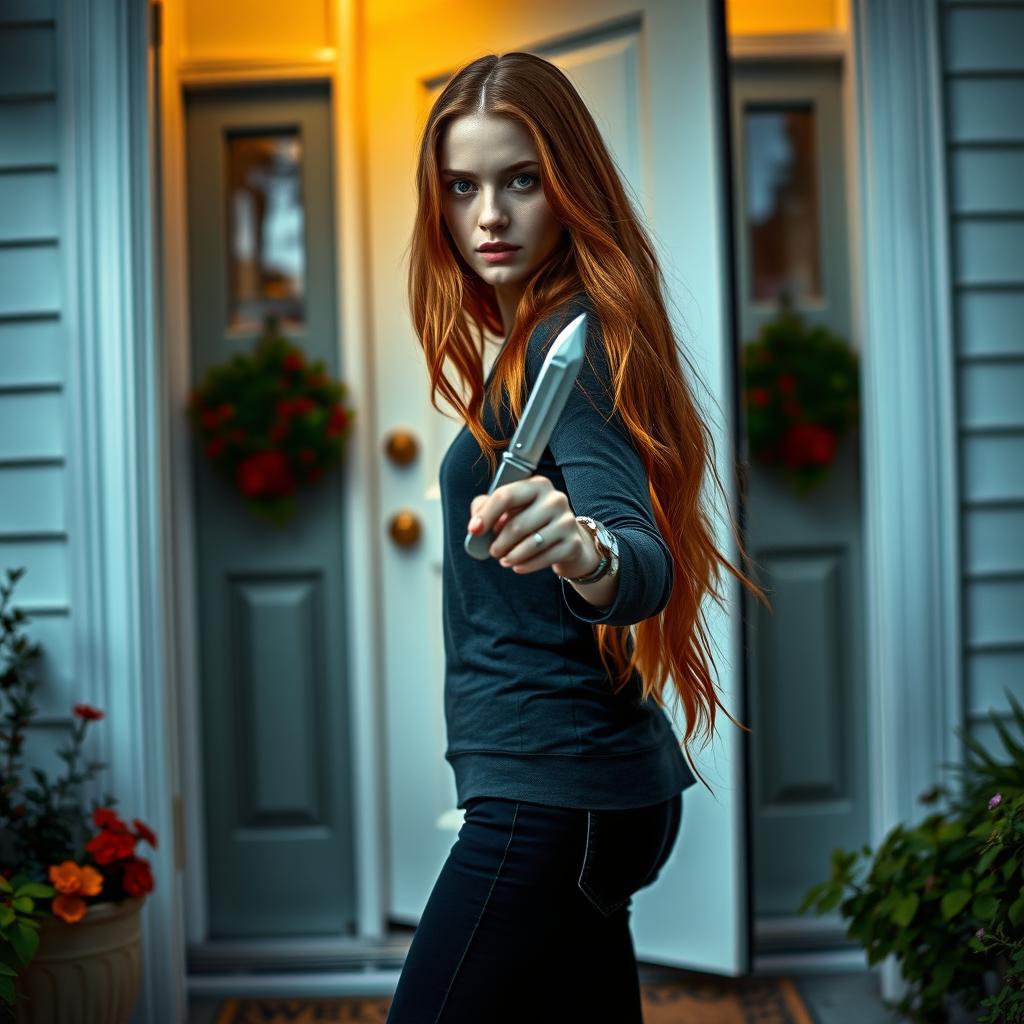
[186,316,354,526]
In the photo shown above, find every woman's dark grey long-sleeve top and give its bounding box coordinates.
[440,294,695,810]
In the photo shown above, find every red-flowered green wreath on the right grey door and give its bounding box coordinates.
[742,308,860,495]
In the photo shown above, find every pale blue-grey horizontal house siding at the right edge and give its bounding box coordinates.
[939,2,1024,751]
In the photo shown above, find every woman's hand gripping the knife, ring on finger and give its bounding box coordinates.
[467,475,600,577]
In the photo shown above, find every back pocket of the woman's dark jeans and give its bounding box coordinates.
[577,794,681,916]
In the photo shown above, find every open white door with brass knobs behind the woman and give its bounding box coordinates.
[366,0,748,974]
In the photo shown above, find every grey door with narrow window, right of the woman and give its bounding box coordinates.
[732,61,868,933]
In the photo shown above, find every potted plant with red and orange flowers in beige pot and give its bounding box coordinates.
[0,568,157,1024]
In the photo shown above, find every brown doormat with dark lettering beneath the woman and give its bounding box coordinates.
[216,974,814,1024]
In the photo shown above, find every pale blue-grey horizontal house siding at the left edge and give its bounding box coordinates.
[0,0,74,771]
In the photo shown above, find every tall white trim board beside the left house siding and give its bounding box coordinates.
[57,0,186,1024]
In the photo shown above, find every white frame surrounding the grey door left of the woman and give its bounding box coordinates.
[151,0,387,992]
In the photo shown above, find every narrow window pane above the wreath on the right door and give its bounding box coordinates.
[743,105,821,305]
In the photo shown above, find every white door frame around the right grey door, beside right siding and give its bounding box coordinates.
[729,0,963,997]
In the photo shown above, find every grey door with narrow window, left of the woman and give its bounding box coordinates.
[186,85,355,938]
